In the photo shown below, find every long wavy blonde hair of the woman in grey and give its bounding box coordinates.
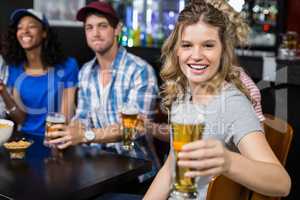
[160,0,250,111]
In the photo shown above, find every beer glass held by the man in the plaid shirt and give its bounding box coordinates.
[45,112,66,158]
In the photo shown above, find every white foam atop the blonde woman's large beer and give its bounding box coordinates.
[171,103,204,124]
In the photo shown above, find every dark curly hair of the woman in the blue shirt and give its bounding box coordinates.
[2,16,65,66]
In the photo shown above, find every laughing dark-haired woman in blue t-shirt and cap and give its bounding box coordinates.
[0,9,78,135]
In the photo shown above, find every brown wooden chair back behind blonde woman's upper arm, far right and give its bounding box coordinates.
[251,114,293,200]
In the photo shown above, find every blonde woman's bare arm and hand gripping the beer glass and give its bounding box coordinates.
[178,132,291,196]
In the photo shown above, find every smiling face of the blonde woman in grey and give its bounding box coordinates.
[177,20,222,90]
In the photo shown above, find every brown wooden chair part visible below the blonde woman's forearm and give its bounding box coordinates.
[206,175,250,200]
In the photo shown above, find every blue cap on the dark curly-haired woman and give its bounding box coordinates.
[10,8,49,27]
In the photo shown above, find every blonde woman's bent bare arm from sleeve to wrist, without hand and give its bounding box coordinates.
[225,133,291,196]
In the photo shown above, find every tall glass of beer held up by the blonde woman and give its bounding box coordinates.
[169,103,205,200]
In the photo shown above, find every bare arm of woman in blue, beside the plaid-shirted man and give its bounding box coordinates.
[61,87,76,122]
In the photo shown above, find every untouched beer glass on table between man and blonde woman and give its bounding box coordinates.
[121,104,138,151]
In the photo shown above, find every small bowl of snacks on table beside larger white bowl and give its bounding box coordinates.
[3,139,33,159]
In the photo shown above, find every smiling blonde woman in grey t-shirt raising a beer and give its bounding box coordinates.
[144,0,291,200]
